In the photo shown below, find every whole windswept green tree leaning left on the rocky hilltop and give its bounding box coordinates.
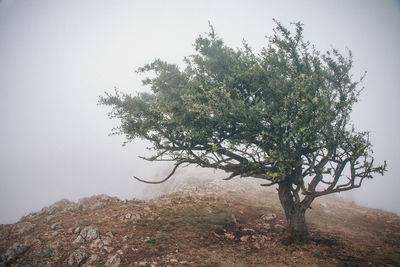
[99,21,386,241]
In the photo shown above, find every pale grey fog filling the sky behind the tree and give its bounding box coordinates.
[0,0,400,223]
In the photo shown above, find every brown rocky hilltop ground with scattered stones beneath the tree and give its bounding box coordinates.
[0,179,400,267]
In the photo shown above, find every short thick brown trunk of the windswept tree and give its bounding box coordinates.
[278,182,310,242]
